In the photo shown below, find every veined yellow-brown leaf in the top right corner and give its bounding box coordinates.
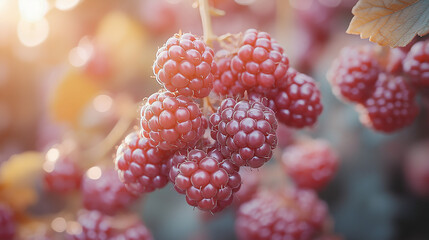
[347,0,429,47]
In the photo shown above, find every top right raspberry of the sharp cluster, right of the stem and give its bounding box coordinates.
[231,29,289,89]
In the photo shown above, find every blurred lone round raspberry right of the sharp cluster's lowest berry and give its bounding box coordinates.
[282,140,338,190]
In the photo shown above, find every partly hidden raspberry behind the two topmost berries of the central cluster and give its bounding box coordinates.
[213,50,246,97]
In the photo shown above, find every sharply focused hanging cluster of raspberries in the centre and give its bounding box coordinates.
[114,29,323,213]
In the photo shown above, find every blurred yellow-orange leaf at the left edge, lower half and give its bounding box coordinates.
[0,152,44,211]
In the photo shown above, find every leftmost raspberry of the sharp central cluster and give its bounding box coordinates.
[115,132,169,193]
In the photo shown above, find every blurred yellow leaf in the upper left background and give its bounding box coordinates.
[50,70,100,126]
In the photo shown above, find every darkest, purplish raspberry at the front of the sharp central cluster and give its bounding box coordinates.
[210,98,277,168]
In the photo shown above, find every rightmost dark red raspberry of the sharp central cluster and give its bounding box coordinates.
[268,68,323,128]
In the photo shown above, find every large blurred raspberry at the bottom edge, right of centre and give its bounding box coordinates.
[235,190,328,240]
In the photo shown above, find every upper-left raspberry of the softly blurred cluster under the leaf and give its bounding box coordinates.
[327,45,380,103]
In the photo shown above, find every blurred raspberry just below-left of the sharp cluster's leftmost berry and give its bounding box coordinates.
[82,169,137,214]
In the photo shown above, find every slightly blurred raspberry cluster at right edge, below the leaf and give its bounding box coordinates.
[327,40,422,133]
